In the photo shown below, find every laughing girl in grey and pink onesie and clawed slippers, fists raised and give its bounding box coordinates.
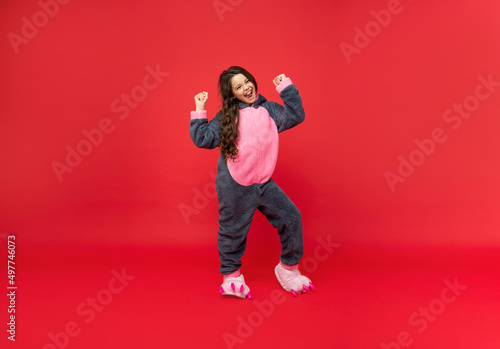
[189,66,314,299]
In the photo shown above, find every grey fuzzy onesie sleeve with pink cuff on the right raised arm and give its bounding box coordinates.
[268,78,305,132]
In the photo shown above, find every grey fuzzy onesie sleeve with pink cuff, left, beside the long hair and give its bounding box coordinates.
[189,110,222,149]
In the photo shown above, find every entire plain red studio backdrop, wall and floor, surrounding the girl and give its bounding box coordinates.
[0,0,500,349]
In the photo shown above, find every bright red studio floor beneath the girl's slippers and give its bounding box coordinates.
[2,244,500,349]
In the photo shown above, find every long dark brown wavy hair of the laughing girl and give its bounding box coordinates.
[219,66,257,161]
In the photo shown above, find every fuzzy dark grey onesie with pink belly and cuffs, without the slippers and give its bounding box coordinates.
[190,78,305,275]
